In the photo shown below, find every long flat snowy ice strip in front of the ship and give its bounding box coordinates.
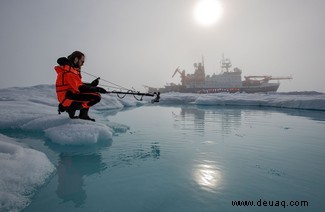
[161,92,325,110]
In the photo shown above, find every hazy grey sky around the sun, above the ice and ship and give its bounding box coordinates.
[0,0,325,92]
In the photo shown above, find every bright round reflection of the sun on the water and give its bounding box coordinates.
[193,160,222,192]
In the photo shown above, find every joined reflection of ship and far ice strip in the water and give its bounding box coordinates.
[173,106,325,135]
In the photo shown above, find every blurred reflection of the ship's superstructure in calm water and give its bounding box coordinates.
[174,106,242,135]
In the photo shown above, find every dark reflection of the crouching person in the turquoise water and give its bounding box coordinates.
[56,153,107,207]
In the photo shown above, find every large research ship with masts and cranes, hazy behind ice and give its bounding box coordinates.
[147,56,292,93]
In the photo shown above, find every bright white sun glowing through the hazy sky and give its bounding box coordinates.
[194,0,222,26]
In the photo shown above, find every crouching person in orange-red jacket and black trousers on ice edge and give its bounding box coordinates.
[54,51,107,121]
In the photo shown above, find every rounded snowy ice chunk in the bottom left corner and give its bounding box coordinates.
[0,134,55,211]
